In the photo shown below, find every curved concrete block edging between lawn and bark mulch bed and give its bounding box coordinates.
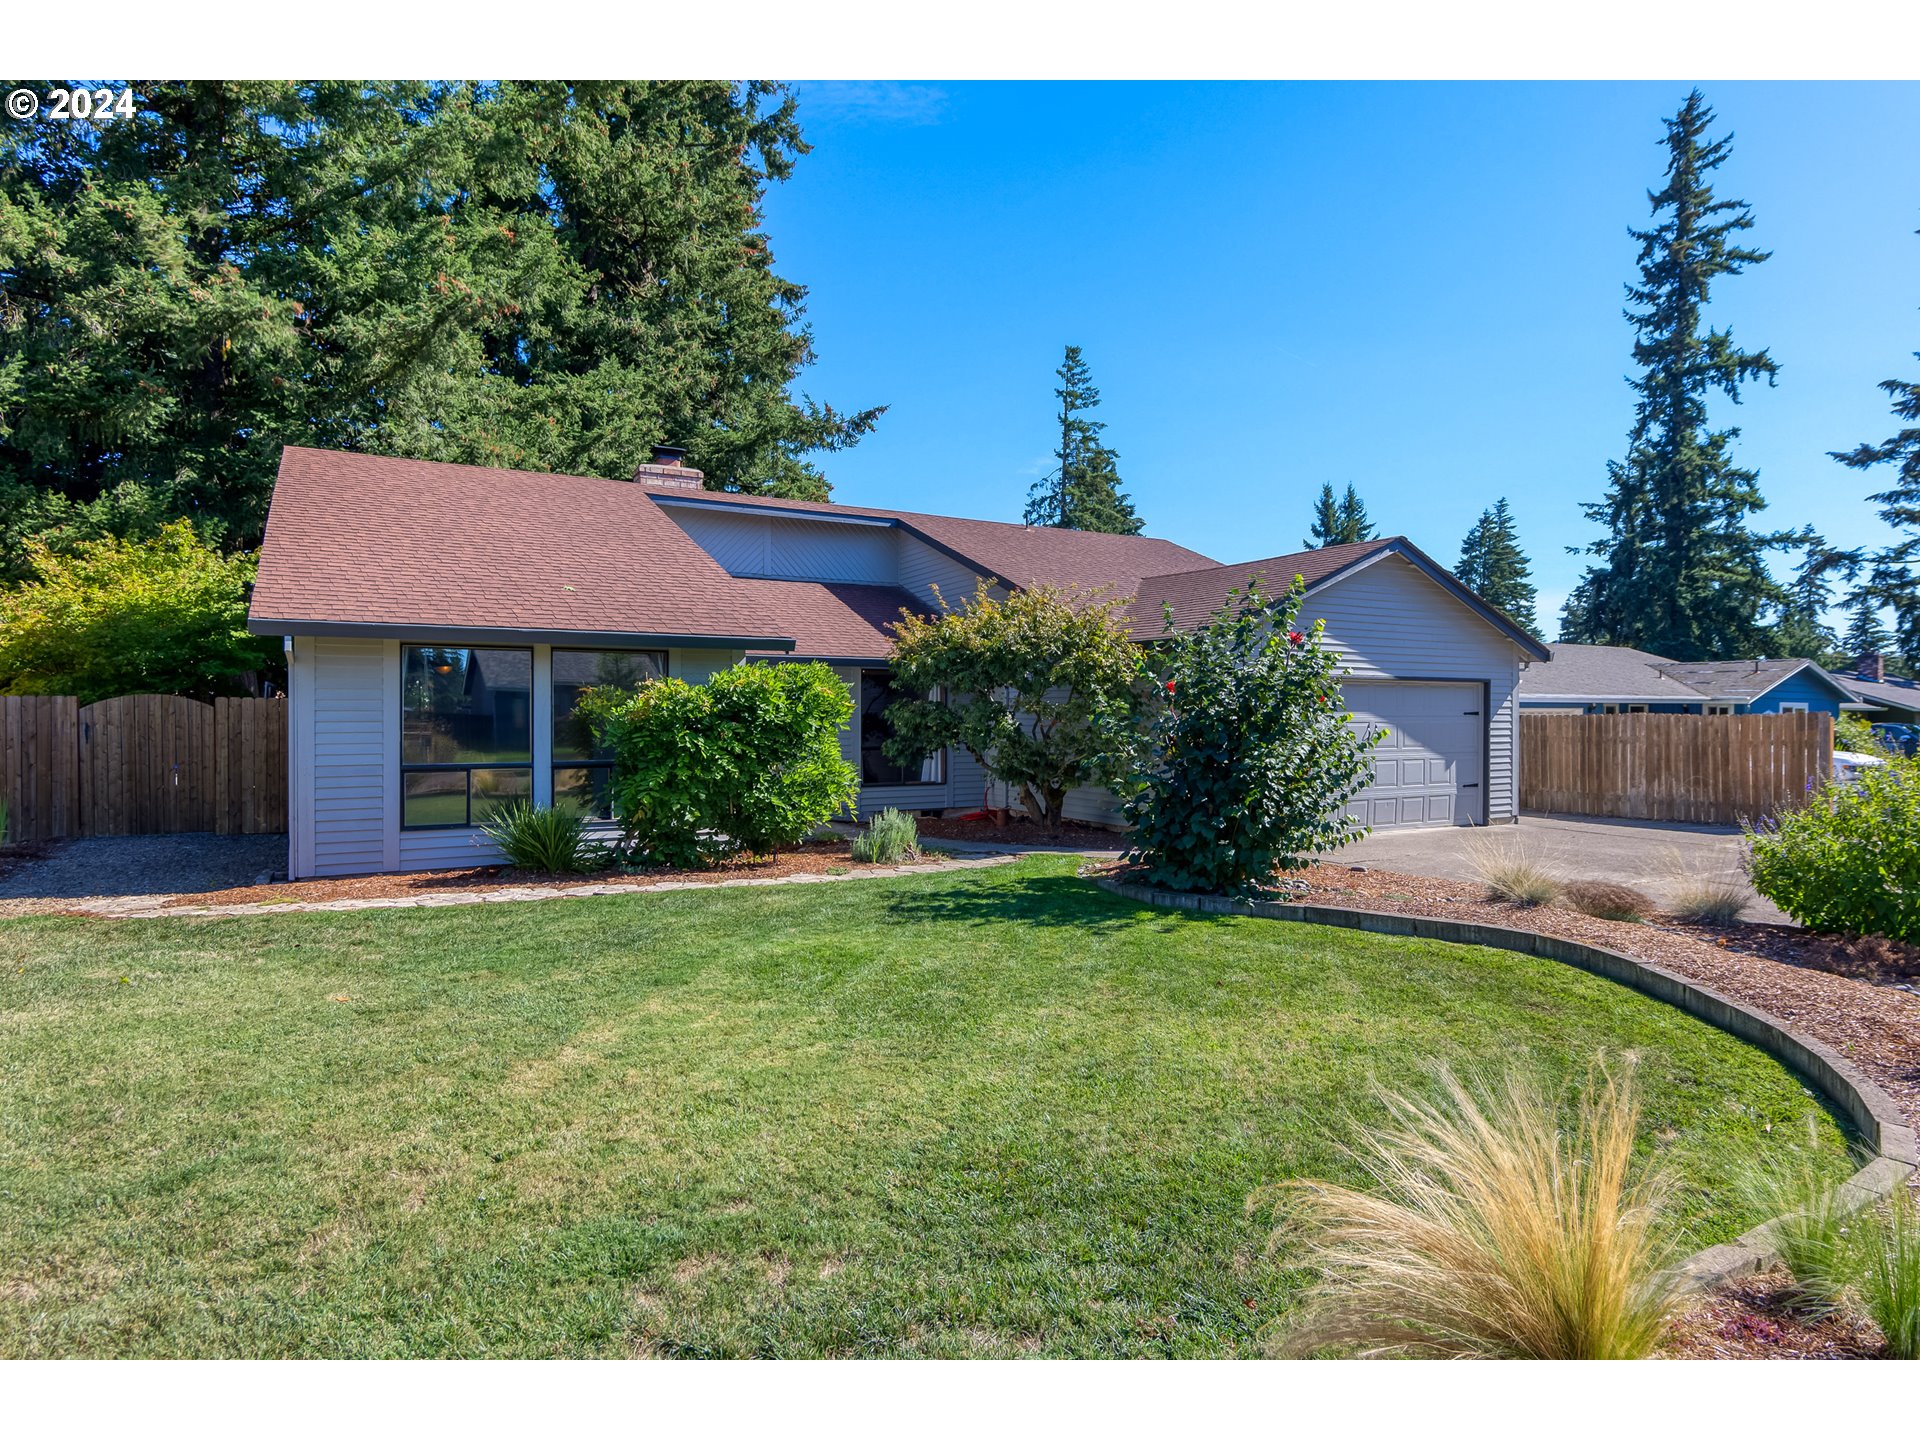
[1098,877,1920,1288]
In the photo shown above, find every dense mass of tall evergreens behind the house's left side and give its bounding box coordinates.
[0,81,877,578]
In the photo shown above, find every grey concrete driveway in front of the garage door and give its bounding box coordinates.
[1327,814,1791,924]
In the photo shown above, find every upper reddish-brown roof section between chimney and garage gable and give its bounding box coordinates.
[645,488,1215,601]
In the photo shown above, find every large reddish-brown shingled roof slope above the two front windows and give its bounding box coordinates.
[248,445,793,651]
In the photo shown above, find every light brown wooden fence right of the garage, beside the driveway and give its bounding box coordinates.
[1521,712,1834,826]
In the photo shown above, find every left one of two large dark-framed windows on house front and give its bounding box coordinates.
[399,645,534,829]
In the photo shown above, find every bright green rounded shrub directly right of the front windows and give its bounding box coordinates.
[578,662,860,868]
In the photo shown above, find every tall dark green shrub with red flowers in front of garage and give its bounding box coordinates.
[1125,576,1377,897]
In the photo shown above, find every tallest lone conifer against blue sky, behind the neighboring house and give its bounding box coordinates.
[1561,90,1784,660]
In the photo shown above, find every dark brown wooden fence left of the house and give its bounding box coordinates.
[0,695,286,841]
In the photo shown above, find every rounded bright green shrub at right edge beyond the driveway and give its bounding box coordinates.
[1747,760,1920,941]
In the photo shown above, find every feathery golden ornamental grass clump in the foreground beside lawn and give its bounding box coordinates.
[1275,1064,1678,1359]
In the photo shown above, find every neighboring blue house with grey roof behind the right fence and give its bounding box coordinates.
[1521,645,1860,716]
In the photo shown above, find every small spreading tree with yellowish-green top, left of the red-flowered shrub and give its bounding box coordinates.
[887,586,1144,826]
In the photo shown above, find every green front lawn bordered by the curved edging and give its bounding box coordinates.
[0,858,1847,1356]
